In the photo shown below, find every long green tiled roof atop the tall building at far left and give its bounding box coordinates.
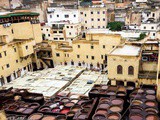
[0,12,39,18]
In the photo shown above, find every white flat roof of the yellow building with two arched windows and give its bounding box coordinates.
[111,45,141,56]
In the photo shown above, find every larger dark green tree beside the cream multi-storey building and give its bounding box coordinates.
[107,22,124,31]
